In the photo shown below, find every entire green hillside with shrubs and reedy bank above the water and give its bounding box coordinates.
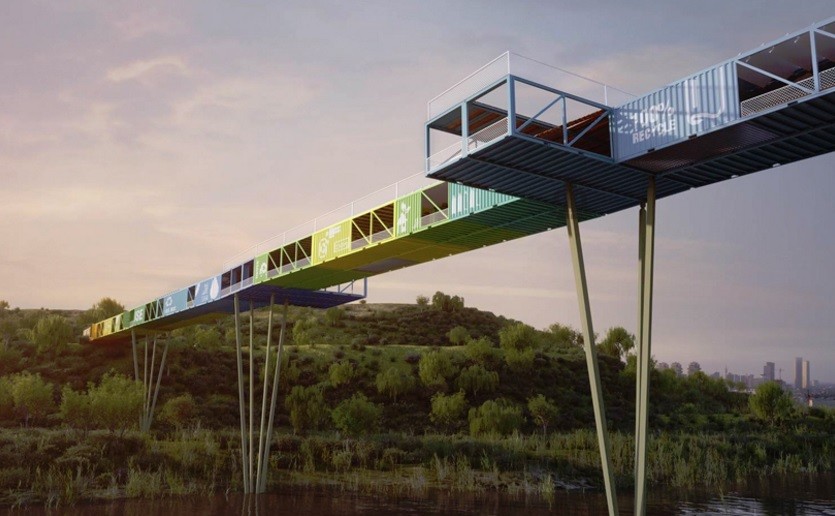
[0,292,835,506]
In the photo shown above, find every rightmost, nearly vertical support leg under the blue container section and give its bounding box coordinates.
[635,178,655,515]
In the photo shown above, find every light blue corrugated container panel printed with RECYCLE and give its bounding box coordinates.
[613,63,739,159]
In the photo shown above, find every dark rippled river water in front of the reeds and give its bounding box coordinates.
[0,474,835,516]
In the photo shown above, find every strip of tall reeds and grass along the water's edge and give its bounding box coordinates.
[0,429,835,507]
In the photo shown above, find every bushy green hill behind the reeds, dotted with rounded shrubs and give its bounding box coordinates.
[0,292,825,435]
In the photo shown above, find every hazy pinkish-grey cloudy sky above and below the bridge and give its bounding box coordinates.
[0,0,835,382]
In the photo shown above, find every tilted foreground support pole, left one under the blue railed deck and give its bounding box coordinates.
[565,183,618,515]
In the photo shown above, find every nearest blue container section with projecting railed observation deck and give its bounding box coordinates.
[425,18,835,212]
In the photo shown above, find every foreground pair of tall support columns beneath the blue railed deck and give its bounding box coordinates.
[566,178,655,515]
